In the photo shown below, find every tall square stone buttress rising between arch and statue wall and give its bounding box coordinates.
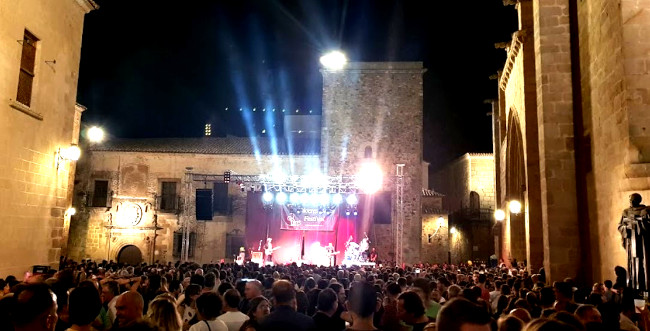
[533,0,580,281]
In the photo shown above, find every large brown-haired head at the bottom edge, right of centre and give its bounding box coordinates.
[436,298,491,331]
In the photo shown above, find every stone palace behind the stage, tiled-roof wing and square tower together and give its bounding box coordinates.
[70,62,430,263]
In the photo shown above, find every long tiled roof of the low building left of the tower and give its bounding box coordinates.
[91,137,320,155]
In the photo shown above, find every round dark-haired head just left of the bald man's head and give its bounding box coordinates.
[68,287,102,326]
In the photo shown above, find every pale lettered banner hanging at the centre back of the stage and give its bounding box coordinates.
[280,205,338,231]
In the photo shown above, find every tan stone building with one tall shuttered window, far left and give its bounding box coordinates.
[0,0,97,277]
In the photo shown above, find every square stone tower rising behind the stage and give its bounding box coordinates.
[321,62,425,263]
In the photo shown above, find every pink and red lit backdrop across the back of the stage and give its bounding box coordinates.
[246,192,373,264]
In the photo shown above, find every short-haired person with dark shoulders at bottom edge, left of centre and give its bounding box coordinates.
[261,280,314,331]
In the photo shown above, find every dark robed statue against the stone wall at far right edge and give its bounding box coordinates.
[618,193,650,291]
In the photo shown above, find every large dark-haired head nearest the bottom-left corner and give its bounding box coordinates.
[12,284,58,331]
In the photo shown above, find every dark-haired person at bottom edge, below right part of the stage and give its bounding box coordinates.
[347,282,380,331]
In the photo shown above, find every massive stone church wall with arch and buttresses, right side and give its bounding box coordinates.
[494,0,650,282]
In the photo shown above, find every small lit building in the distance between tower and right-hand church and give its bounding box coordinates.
[433,153,496,263]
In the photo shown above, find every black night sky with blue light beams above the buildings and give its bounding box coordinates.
[78,0,517,169]
